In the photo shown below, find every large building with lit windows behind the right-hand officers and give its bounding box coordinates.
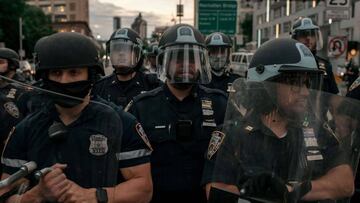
[252,0,360,70]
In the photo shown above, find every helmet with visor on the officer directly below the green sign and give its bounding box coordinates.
[205,32,232,76]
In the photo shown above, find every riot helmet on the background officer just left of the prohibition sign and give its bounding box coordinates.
[291,18,323,54]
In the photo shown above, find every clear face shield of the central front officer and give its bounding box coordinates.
[158,44,211,84]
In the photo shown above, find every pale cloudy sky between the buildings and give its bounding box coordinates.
[89,0,194,40]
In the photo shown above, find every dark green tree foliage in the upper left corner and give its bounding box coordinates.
[0,0,54,58]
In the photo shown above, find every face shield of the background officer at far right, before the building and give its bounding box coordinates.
[293,29,323,50]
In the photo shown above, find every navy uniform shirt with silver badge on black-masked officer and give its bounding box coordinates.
[1,97,151,188]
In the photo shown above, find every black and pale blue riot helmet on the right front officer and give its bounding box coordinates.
[247,38,322,116]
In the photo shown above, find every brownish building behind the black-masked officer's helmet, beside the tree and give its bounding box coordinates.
[26,0,92,36]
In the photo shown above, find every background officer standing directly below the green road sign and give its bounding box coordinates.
[205,32,239,93]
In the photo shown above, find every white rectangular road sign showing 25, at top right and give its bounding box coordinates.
[325,0,350,20]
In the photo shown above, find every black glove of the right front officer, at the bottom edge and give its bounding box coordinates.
[239,173,289,202]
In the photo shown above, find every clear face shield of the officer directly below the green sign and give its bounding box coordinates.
[208,46,230,72]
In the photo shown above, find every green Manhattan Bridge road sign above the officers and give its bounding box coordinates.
[198,0,237,35]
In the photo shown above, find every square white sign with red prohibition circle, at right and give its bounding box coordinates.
[328,36,347,58]
